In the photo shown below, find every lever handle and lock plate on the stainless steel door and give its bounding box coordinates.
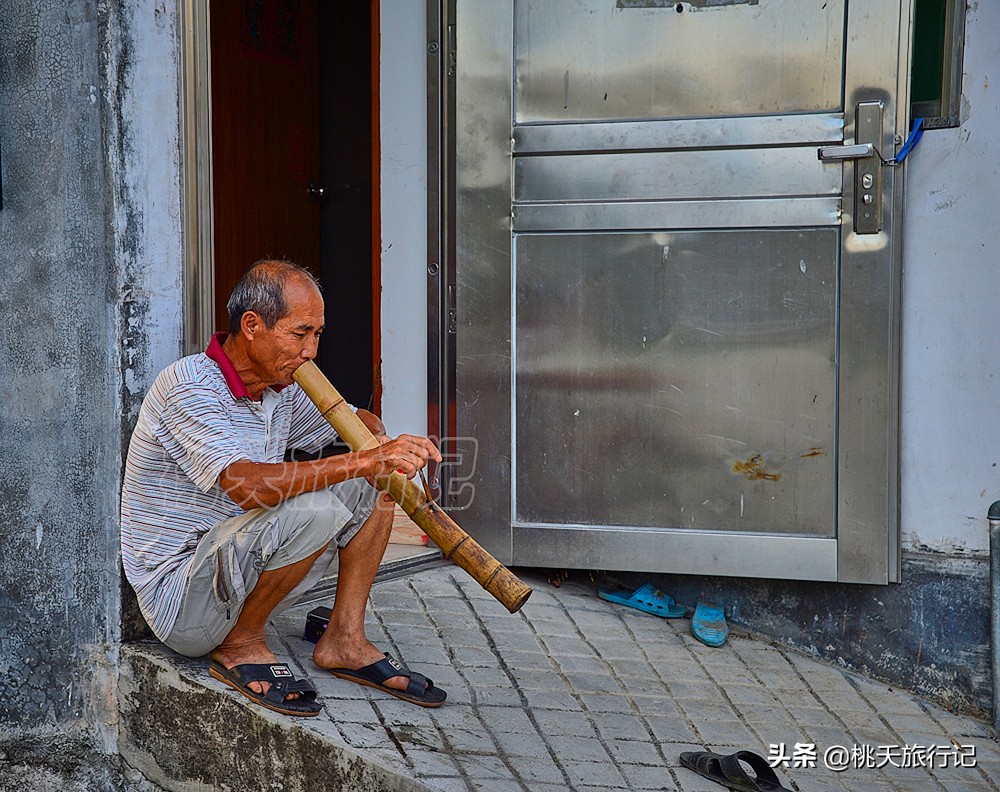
[816,102,884,234]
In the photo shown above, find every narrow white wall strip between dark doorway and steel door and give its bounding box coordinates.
[379,0,427,435]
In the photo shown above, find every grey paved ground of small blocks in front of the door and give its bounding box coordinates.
[252,566,1000,792]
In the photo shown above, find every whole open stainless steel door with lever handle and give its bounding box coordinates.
[454,0,908,582]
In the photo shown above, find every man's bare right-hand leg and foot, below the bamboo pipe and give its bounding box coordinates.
[313,495,408,690]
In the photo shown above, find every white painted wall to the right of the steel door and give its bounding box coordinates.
[900,0,1000,554]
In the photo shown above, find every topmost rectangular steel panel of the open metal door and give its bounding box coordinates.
[514,0,844,124]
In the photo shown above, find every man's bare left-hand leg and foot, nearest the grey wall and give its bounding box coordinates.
[212,546,326,700]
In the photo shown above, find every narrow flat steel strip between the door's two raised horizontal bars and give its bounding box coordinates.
[514,146,843,203]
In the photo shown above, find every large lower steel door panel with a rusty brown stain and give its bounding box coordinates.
[512,228,839,536]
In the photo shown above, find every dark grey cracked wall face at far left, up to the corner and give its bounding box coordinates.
[0,0,120,744]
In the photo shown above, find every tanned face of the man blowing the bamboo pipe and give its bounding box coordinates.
[251,278,324,385]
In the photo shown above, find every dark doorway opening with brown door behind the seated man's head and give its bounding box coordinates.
[210,0,379,408]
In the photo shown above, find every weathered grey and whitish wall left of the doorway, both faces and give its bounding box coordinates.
[0,0,180,748]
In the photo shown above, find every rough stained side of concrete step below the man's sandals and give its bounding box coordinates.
[119,643,427,792]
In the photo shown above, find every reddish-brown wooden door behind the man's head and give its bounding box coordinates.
[210,0,320,330]
